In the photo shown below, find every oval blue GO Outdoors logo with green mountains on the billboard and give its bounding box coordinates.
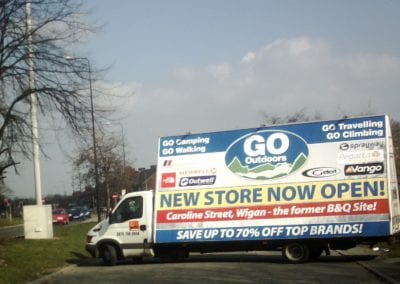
[225,130,308,179]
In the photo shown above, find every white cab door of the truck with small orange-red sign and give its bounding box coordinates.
[109,195,149,256]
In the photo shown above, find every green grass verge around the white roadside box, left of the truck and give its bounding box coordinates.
[0,223,94,283]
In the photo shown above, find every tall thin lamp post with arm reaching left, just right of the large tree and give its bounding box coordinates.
[65,56,101,222]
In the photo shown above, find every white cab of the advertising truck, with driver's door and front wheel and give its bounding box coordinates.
[86,191,154,265]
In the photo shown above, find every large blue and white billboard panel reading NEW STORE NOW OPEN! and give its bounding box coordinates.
[155,116,400,243]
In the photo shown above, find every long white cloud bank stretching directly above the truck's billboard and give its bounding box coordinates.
[108,37,400,165]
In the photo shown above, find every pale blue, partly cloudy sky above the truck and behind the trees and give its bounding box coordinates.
[7,0,400,197]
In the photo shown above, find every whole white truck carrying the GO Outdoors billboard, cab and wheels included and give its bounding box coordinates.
[86,115,400,265]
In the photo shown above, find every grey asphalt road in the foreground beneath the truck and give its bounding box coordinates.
[34,251,394,284]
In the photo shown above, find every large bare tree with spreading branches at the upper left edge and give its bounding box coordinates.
[0,0,99,176]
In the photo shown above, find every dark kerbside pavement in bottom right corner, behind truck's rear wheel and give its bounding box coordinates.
[337,246,400,284]
